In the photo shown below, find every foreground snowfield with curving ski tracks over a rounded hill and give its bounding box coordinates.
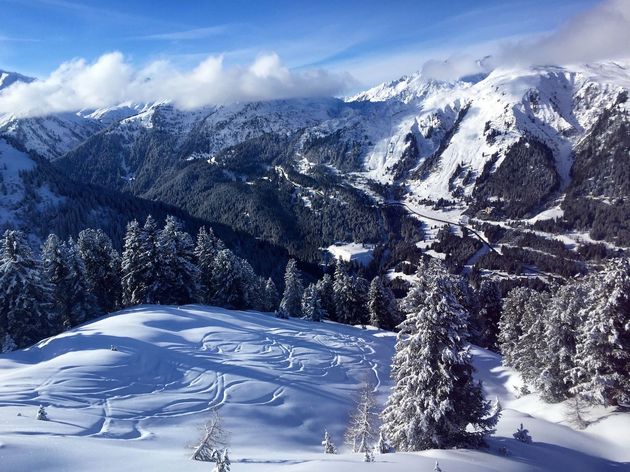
[0,306,630,472]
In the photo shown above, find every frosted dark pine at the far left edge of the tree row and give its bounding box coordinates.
[0,230,53,350]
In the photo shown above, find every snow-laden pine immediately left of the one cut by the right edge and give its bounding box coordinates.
[534,281,586,402]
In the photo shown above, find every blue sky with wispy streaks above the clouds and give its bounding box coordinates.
[0,0,598,85]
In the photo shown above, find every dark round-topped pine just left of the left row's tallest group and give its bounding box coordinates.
[77,229,121,313]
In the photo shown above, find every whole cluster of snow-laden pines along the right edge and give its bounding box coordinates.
[499,259,630,406]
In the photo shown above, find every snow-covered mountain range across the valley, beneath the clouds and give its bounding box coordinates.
[0,62,630,272]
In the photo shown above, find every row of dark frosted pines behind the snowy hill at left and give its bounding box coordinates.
[0,216,401,352]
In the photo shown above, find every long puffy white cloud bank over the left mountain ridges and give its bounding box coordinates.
[0,52,353,116]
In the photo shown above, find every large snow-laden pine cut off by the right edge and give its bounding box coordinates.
[572,259,630,406]
